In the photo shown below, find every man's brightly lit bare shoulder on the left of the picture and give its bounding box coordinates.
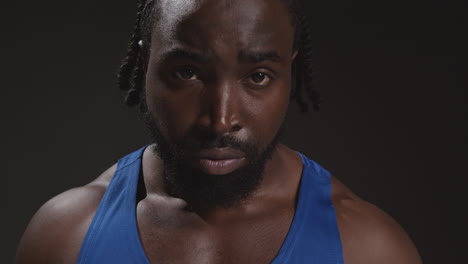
[16,165,116,264]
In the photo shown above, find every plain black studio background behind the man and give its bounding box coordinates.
[0,0,468,264]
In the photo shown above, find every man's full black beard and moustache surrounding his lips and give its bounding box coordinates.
[140,98,282,211]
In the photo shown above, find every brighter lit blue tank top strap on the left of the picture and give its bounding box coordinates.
[77,147,149,264]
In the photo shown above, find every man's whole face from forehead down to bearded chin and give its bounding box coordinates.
[145,0,294,210]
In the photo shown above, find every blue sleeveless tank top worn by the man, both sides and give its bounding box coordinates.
[78,148,343,264]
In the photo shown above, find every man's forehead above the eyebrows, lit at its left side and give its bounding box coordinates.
[151,0,294,56]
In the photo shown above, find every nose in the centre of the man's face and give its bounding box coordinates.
[200,82,242,136]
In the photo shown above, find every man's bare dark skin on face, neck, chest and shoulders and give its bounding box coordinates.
[17,0,421,264]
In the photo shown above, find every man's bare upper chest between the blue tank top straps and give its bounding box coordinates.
[137,202,294,264]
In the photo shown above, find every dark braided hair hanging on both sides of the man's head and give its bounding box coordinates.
[117,0,322,112]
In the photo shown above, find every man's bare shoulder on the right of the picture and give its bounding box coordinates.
[332,177,422,264]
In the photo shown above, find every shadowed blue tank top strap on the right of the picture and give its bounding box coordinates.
[272,152,344,264]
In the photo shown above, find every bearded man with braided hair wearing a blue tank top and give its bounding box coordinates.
[17,0,421,264]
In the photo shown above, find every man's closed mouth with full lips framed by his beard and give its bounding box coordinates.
[194,148,246,175]
